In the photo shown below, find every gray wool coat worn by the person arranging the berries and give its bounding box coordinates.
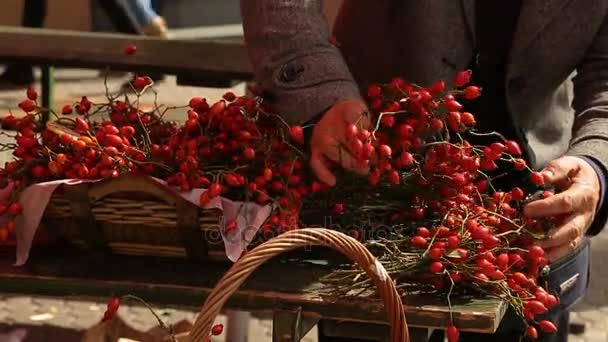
[241,0,608,168]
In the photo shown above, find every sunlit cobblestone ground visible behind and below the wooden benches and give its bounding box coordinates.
[0,70,608,342]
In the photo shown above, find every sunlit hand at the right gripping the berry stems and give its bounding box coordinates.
[524,156,600,261]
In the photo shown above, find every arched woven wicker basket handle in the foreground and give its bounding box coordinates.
[185,228,409,342]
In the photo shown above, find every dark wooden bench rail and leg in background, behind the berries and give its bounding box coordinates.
[0,26,252,120]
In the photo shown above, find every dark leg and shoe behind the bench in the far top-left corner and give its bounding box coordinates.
[0,0,47,89]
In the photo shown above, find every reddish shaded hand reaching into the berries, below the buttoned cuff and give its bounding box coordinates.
[310,99,370,186]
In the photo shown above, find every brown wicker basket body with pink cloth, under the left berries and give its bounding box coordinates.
[42,175,226,260]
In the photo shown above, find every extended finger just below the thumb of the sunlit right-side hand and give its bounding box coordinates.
[524,182,594,218]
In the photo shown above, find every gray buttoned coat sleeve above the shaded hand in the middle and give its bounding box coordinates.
[241,0,360,124]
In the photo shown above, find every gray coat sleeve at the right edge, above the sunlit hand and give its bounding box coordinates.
[567,11,608,234]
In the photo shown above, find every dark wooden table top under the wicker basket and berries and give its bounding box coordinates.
[0,247,506,333]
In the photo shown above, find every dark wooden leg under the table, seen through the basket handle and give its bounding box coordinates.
[272,307,319,342]
